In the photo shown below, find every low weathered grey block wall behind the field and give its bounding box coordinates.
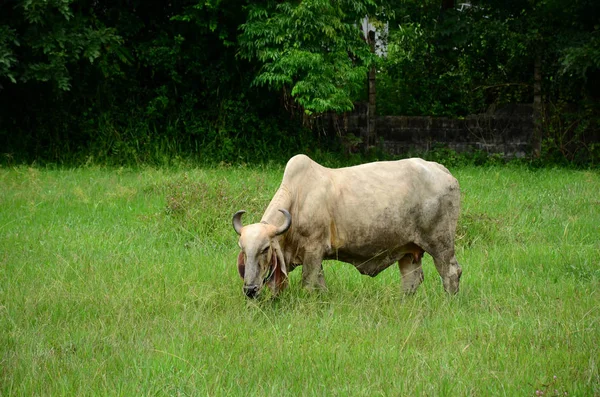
[344,105,533,157]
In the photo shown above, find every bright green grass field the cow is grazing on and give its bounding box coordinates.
[0,162,600,396]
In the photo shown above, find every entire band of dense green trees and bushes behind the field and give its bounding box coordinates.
[0,0,600,165]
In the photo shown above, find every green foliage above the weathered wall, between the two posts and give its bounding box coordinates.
[378,3,532,117]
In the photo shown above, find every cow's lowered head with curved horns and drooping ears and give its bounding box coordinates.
[232,209,292,298]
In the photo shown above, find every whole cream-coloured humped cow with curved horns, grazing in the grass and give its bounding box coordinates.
[232,155,462,298]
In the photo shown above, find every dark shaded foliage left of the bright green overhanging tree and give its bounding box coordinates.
[0,0,323,164]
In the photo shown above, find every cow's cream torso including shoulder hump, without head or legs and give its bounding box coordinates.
[282,155,459,250]
